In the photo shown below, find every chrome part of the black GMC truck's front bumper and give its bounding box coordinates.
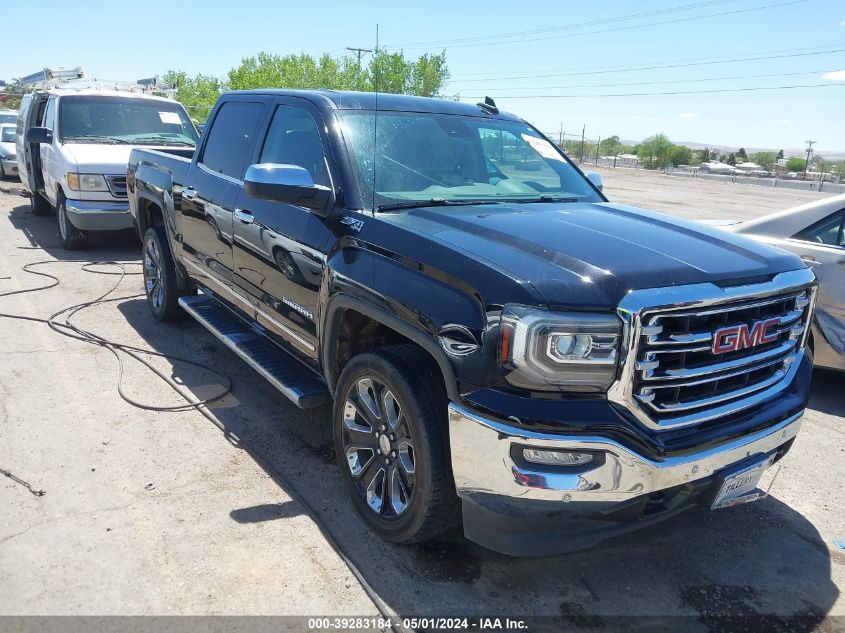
[449,403,803,504]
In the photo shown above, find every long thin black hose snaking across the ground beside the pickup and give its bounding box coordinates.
[0,252,406,633]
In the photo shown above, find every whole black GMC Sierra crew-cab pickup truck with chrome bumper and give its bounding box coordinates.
[127,90,815,555]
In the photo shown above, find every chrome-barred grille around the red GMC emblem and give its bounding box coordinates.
[632,290,812,426]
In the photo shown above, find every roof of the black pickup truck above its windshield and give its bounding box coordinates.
[225,88,520,120]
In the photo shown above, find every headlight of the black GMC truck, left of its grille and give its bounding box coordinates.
[499,305,622,392]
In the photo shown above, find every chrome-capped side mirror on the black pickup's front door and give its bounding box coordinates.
[244,163,334,217]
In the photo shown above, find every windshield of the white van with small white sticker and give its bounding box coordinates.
[59,95,197,145]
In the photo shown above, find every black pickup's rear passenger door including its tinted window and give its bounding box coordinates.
[182,97,266,316]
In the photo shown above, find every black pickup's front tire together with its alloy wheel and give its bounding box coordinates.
[333,345,460,544]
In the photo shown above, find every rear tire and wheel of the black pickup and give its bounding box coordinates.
[142,224,193,321]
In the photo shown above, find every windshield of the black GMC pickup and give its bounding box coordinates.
[341,110,601,208]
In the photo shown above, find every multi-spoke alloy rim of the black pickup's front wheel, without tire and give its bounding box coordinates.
[342,376,416,520]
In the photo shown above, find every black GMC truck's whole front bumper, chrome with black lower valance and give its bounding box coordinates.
[449,403,803,556]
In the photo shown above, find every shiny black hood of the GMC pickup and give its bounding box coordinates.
[382,203,805,309]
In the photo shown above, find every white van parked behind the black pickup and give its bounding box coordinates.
[15,89,198,249]
